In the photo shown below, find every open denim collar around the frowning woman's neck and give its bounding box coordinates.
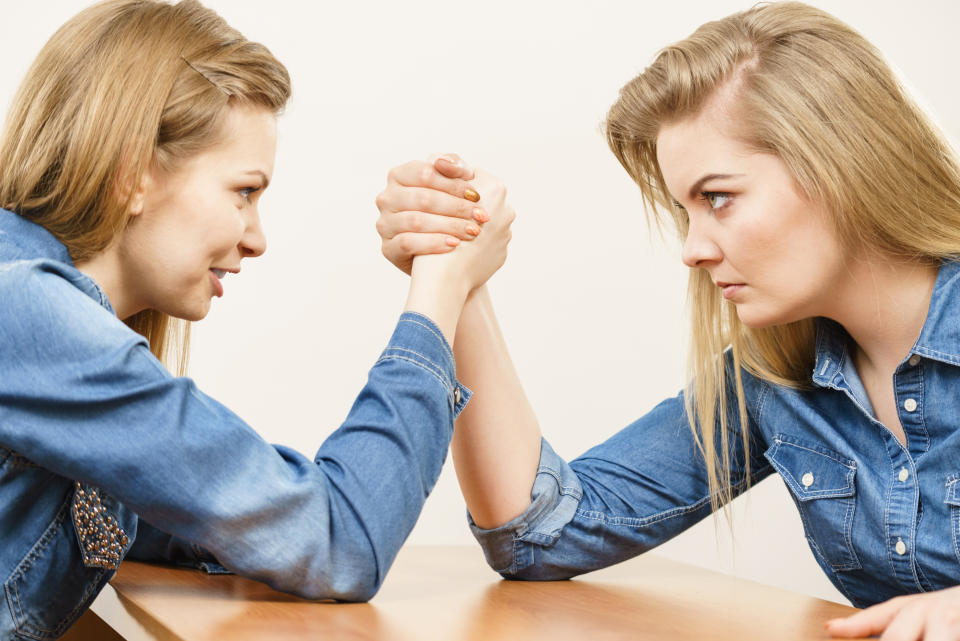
[813,261,960,387]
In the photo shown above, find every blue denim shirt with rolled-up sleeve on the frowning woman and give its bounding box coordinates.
[471,262,960,607]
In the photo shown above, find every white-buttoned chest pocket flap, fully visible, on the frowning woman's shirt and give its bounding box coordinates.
[764,434,857,501]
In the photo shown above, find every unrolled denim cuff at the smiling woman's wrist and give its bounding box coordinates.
[377,312,473,418]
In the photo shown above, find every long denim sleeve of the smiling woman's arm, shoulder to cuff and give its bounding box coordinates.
[0,265,480,600]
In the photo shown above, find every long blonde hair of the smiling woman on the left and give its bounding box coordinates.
[0,0,290,373]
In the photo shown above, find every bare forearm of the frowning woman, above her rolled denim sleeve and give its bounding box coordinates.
[451,287,540,528]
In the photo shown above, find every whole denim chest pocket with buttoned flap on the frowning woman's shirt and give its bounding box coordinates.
[764,434,860,571]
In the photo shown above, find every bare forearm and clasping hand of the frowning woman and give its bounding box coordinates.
[377,156,540,527]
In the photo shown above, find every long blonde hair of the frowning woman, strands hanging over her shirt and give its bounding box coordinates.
[606,2,960,509]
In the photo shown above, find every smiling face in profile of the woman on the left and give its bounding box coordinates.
[120,106,277,320]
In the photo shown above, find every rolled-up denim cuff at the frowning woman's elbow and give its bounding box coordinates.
[467,439,583,576]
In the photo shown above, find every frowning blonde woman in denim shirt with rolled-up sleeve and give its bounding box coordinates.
[380,3,960,639]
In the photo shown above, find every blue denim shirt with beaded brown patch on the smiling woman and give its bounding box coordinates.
[0,210,470,639]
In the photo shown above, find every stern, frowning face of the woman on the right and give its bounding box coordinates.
[657,106,844,327]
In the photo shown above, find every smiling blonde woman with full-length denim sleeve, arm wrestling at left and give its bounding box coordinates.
[0,0,512,639]
